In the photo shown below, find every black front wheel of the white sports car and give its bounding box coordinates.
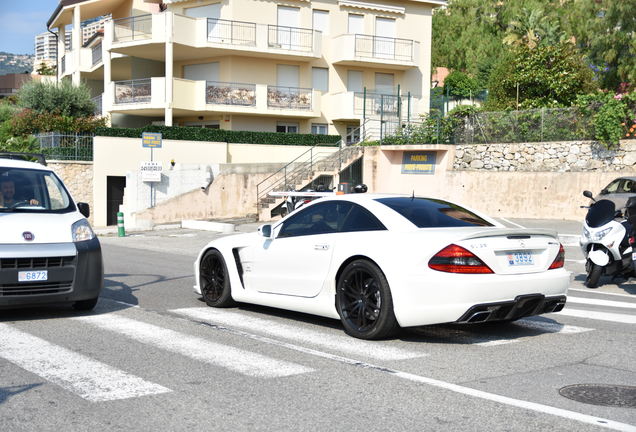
[199,249,234,307]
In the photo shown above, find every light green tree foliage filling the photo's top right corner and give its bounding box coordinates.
[565,0,636,90]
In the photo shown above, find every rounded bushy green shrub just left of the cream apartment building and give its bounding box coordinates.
[18,81,95,117]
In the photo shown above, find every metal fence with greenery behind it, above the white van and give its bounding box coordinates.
[35,132,93,161]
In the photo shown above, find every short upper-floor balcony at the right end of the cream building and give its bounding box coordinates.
[333,34,419,70]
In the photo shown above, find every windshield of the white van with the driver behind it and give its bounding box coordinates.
[0,167,75,213]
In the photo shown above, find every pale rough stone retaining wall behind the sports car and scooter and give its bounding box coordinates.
[453,140,636,172]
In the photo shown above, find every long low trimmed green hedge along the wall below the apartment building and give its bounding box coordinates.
[95,126,340,147]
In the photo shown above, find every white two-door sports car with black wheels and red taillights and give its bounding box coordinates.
[194,194,570,339]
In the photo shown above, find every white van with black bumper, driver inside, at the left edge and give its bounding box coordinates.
[0,154,104,310]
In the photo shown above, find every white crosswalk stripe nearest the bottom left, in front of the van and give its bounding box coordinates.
[0,324,172,402]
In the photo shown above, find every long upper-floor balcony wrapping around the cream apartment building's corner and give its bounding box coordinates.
[105,12,322,61]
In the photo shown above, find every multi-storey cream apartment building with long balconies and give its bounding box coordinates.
[48,0,446,140]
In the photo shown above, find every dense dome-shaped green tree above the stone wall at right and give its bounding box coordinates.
[486,43,594,110]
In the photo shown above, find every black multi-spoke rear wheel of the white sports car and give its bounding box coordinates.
[336,259,399,339]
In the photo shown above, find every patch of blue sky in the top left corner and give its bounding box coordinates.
[0,0,59,54]
